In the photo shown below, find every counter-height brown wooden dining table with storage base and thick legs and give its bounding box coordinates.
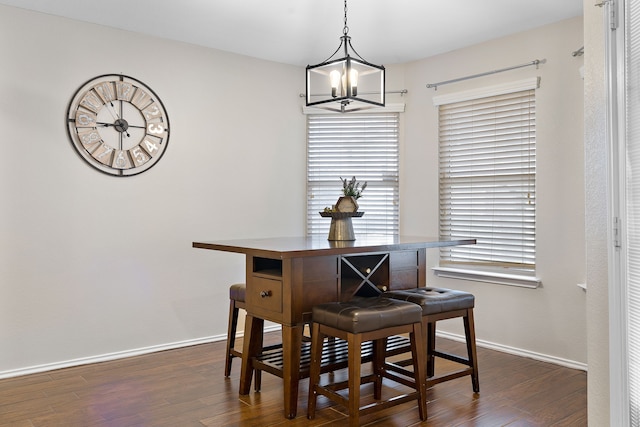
[193,235,476,418]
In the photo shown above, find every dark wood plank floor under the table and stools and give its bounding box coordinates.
[0,333,587,427]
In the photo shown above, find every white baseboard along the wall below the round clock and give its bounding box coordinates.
[0,325,280,380]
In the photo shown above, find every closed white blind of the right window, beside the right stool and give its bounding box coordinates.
[438,89,536,271]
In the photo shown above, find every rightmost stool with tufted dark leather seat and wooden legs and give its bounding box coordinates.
[382,287,480,393]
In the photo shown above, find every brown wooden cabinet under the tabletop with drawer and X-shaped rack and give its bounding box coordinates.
[246,249,426,325]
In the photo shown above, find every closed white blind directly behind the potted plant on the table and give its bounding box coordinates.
[307,113,399,237]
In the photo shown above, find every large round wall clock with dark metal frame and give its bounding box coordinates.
[67,74,169,176]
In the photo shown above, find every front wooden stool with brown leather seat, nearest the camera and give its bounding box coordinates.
[307,297,427,426]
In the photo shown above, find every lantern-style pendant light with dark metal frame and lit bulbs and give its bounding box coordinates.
[306,0,384,113]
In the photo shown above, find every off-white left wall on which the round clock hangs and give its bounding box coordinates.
[0,6,305,375]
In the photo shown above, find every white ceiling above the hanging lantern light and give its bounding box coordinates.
[0,0,583,66]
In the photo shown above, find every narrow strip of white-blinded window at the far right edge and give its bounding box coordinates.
[620,2,640,426]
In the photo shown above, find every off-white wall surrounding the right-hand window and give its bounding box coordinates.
[401,18,587,367]
